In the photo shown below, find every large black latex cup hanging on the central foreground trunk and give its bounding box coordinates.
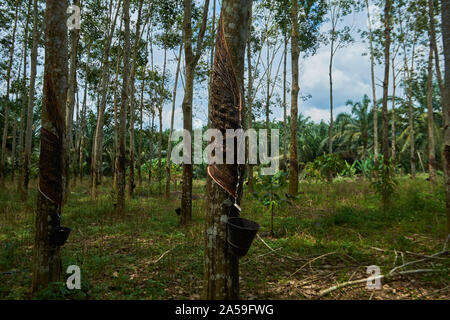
[228,218,261,257]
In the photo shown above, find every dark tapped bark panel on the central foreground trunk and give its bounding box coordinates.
[208,18,243,198]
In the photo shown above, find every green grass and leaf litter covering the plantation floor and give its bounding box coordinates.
[0,177,450,299]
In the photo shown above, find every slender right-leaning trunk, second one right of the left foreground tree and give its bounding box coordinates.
[91,0,121,198]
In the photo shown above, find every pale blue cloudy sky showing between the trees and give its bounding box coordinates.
[155,1,390,129]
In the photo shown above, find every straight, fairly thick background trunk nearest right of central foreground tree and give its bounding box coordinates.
[289,1,300,196]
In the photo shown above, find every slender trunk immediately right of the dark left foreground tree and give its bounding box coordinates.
[63,0,80,202]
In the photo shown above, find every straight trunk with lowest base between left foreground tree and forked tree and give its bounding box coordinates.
[116,0,130,215]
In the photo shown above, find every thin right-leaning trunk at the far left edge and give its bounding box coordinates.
[0,1,20,187]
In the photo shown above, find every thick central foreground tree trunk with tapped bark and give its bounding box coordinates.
[204,0,252,300]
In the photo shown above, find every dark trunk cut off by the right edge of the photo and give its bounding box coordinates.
[441,0,450,236]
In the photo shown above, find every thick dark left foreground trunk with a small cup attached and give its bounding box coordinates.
[32,0,68,293]
